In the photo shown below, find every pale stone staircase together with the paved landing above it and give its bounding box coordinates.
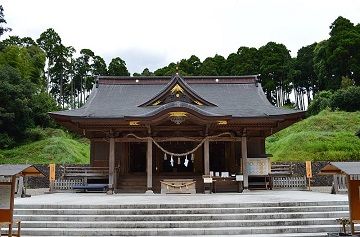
[9,191,360,237]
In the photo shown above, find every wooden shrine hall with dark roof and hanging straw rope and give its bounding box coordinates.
[50,74,304,193]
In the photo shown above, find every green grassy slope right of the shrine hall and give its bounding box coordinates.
[266,111,360,161]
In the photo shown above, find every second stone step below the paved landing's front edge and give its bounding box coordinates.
[14,211,349,221]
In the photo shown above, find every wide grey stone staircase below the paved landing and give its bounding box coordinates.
[10,201,358,237]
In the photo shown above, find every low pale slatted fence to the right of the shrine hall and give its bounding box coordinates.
[272,176,306,189]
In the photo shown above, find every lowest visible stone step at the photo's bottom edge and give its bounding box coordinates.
[17,225,348,236]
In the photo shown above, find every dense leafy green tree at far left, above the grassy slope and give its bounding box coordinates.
[0,45,57,148]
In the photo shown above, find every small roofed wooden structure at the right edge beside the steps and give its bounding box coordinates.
[320,162,360,234]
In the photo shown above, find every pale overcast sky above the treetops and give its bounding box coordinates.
[0,0,360,73]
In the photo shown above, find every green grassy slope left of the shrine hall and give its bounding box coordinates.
[0,129,90,164]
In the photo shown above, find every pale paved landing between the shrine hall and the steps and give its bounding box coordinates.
[15,190,348,205]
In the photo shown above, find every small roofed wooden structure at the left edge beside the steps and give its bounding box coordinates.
[0,165,43,237]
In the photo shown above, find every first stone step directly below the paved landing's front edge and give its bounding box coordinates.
[15,205,349,215]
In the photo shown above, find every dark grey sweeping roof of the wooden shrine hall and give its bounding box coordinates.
[52,76,303,118]
